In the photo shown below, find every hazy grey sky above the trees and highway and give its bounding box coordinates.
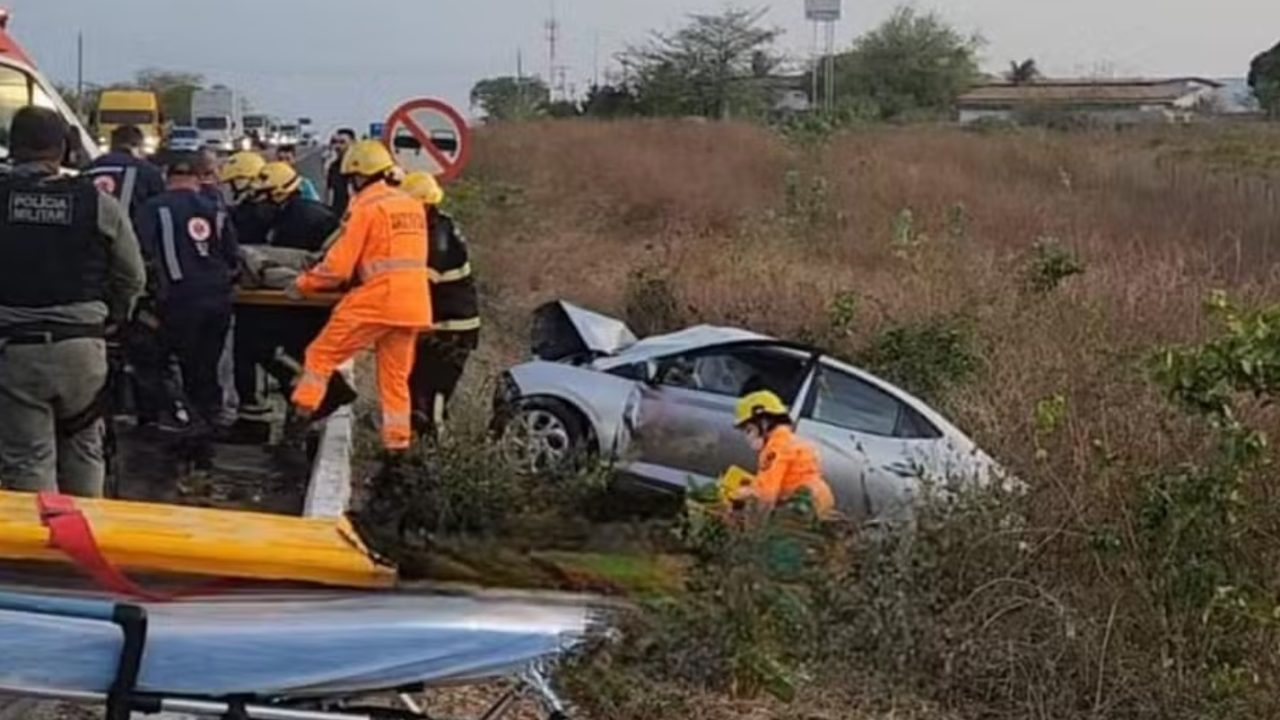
[0,0,1280,129]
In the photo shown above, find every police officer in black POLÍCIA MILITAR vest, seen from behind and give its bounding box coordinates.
[0,106,145,496]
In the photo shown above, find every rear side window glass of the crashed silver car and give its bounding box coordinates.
[805,366,940,438]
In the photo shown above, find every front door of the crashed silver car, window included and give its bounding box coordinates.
[628,345,809,487]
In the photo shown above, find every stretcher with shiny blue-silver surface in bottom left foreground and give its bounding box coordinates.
[0,587,603,720]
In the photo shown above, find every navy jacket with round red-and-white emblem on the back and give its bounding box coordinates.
[137,184,239,307]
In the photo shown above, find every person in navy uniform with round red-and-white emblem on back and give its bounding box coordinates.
[137,154,239,466]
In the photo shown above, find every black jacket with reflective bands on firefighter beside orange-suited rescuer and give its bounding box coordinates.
[426,211,480,332]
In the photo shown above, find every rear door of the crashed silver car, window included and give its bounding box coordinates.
[796,359,940,518]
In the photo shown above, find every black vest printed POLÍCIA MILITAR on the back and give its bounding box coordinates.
[0,177,110,307]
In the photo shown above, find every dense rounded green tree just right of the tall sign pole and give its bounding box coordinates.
[819,6,982,120]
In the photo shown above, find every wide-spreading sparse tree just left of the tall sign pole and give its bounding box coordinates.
[620,9,781,118]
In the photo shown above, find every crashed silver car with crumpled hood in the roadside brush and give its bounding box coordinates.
[494,302,1000,518]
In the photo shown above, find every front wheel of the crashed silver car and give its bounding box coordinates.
[500,397,589,475]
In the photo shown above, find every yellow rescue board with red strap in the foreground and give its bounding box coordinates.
[0,492,396,588]
